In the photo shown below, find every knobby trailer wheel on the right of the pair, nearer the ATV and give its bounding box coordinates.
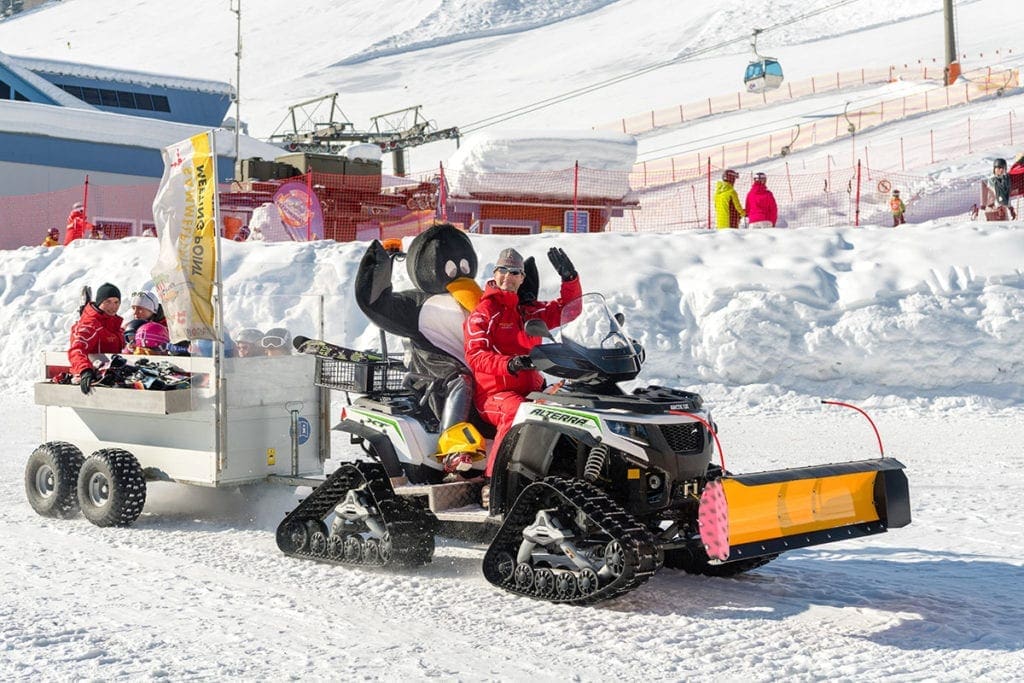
[78,449,145,526]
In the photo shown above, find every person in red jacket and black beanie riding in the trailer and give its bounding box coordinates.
[68,283,124,393]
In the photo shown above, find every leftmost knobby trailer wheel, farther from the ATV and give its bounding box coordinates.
[25,441,84,519]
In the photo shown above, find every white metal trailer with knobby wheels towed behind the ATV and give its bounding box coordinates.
[25,351,330,526]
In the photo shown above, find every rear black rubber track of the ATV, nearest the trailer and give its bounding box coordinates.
[276,462,437,566]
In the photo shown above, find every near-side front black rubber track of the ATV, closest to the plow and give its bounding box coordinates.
[483,477,662,605]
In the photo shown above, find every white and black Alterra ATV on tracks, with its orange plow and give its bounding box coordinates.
[278,294,910,604]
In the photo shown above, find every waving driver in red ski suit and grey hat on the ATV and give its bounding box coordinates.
[465,247,583,477]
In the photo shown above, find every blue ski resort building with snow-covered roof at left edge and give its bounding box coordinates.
[0,52,282,249]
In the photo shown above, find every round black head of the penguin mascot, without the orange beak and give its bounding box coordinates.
[406,223,477,294]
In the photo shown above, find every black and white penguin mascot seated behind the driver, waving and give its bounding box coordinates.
[355,223,539,472]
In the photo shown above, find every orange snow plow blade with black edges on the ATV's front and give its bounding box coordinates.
[699,458,910,561]
